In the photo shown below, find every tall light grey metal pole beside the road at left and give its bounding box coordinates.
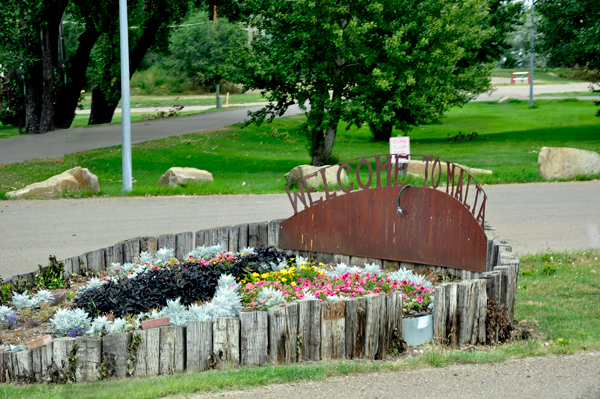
[119,0,133,192]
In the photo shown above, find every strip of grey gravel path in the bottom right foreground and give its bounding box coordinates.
[193,352,600,399]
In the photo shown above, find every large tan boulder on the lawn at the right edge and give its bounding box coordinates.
[538,147,600,180]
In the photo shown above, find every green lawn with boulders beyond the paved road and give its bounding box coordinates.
[0,100,600,198]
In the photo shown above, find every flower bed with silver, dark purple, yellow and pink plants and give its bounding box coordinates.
[0,246,434,343]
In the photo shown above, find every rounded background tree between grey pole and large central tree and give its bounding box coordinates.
[166,9,248,86]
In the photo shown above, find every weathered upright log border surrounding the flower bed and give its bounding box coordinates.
[0,220,519,383]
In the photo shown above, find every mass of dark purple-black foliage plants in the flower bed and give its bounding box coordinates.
[75,247,289,317]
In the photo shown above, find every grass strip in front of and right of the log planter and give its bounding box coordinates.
[0,250,600,399]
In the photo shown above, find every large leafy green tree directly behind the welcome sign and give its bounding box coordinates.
[237,0,491,165]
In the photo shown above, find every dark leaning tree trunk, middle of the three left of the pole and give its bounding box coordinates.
[56,21,100,129]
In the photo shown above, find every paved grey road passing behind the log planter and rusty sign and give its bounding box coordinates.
[0,181,600,277]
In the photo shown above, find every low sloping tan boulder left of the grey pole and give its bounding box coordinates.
[6,166,100,199]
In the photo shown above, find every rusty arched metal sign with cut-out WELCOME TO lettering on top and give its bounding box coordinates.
[279,154,487,272]
